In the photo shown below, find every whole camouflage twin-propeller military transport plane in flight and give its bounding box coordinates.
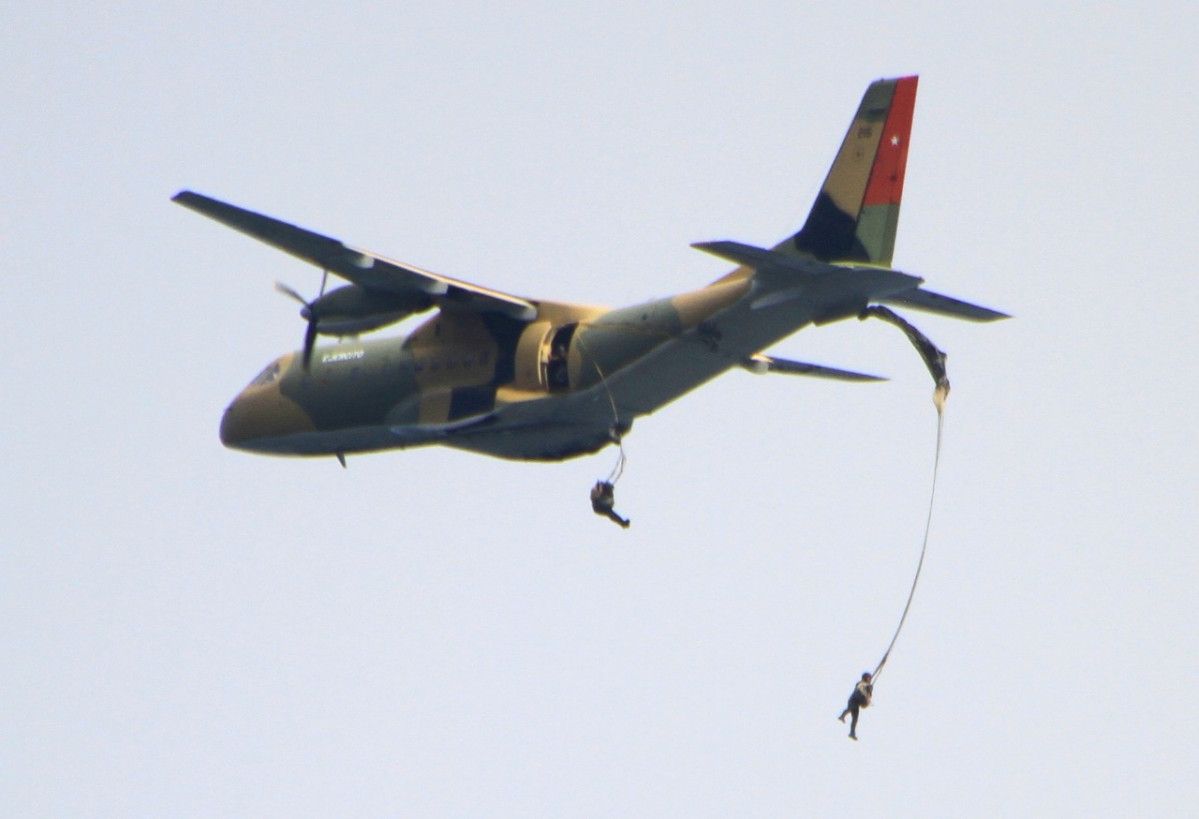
[174,77,1005,465]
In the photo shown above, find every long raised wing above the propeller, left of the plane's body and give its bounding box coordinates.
[171,191,537,321]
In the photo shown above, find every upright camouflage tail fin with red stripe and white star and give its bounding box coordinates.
[775,77,917,266]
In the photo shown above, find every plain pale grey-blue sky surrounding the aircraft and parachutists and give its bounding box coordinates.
[0,0,1199,817]
